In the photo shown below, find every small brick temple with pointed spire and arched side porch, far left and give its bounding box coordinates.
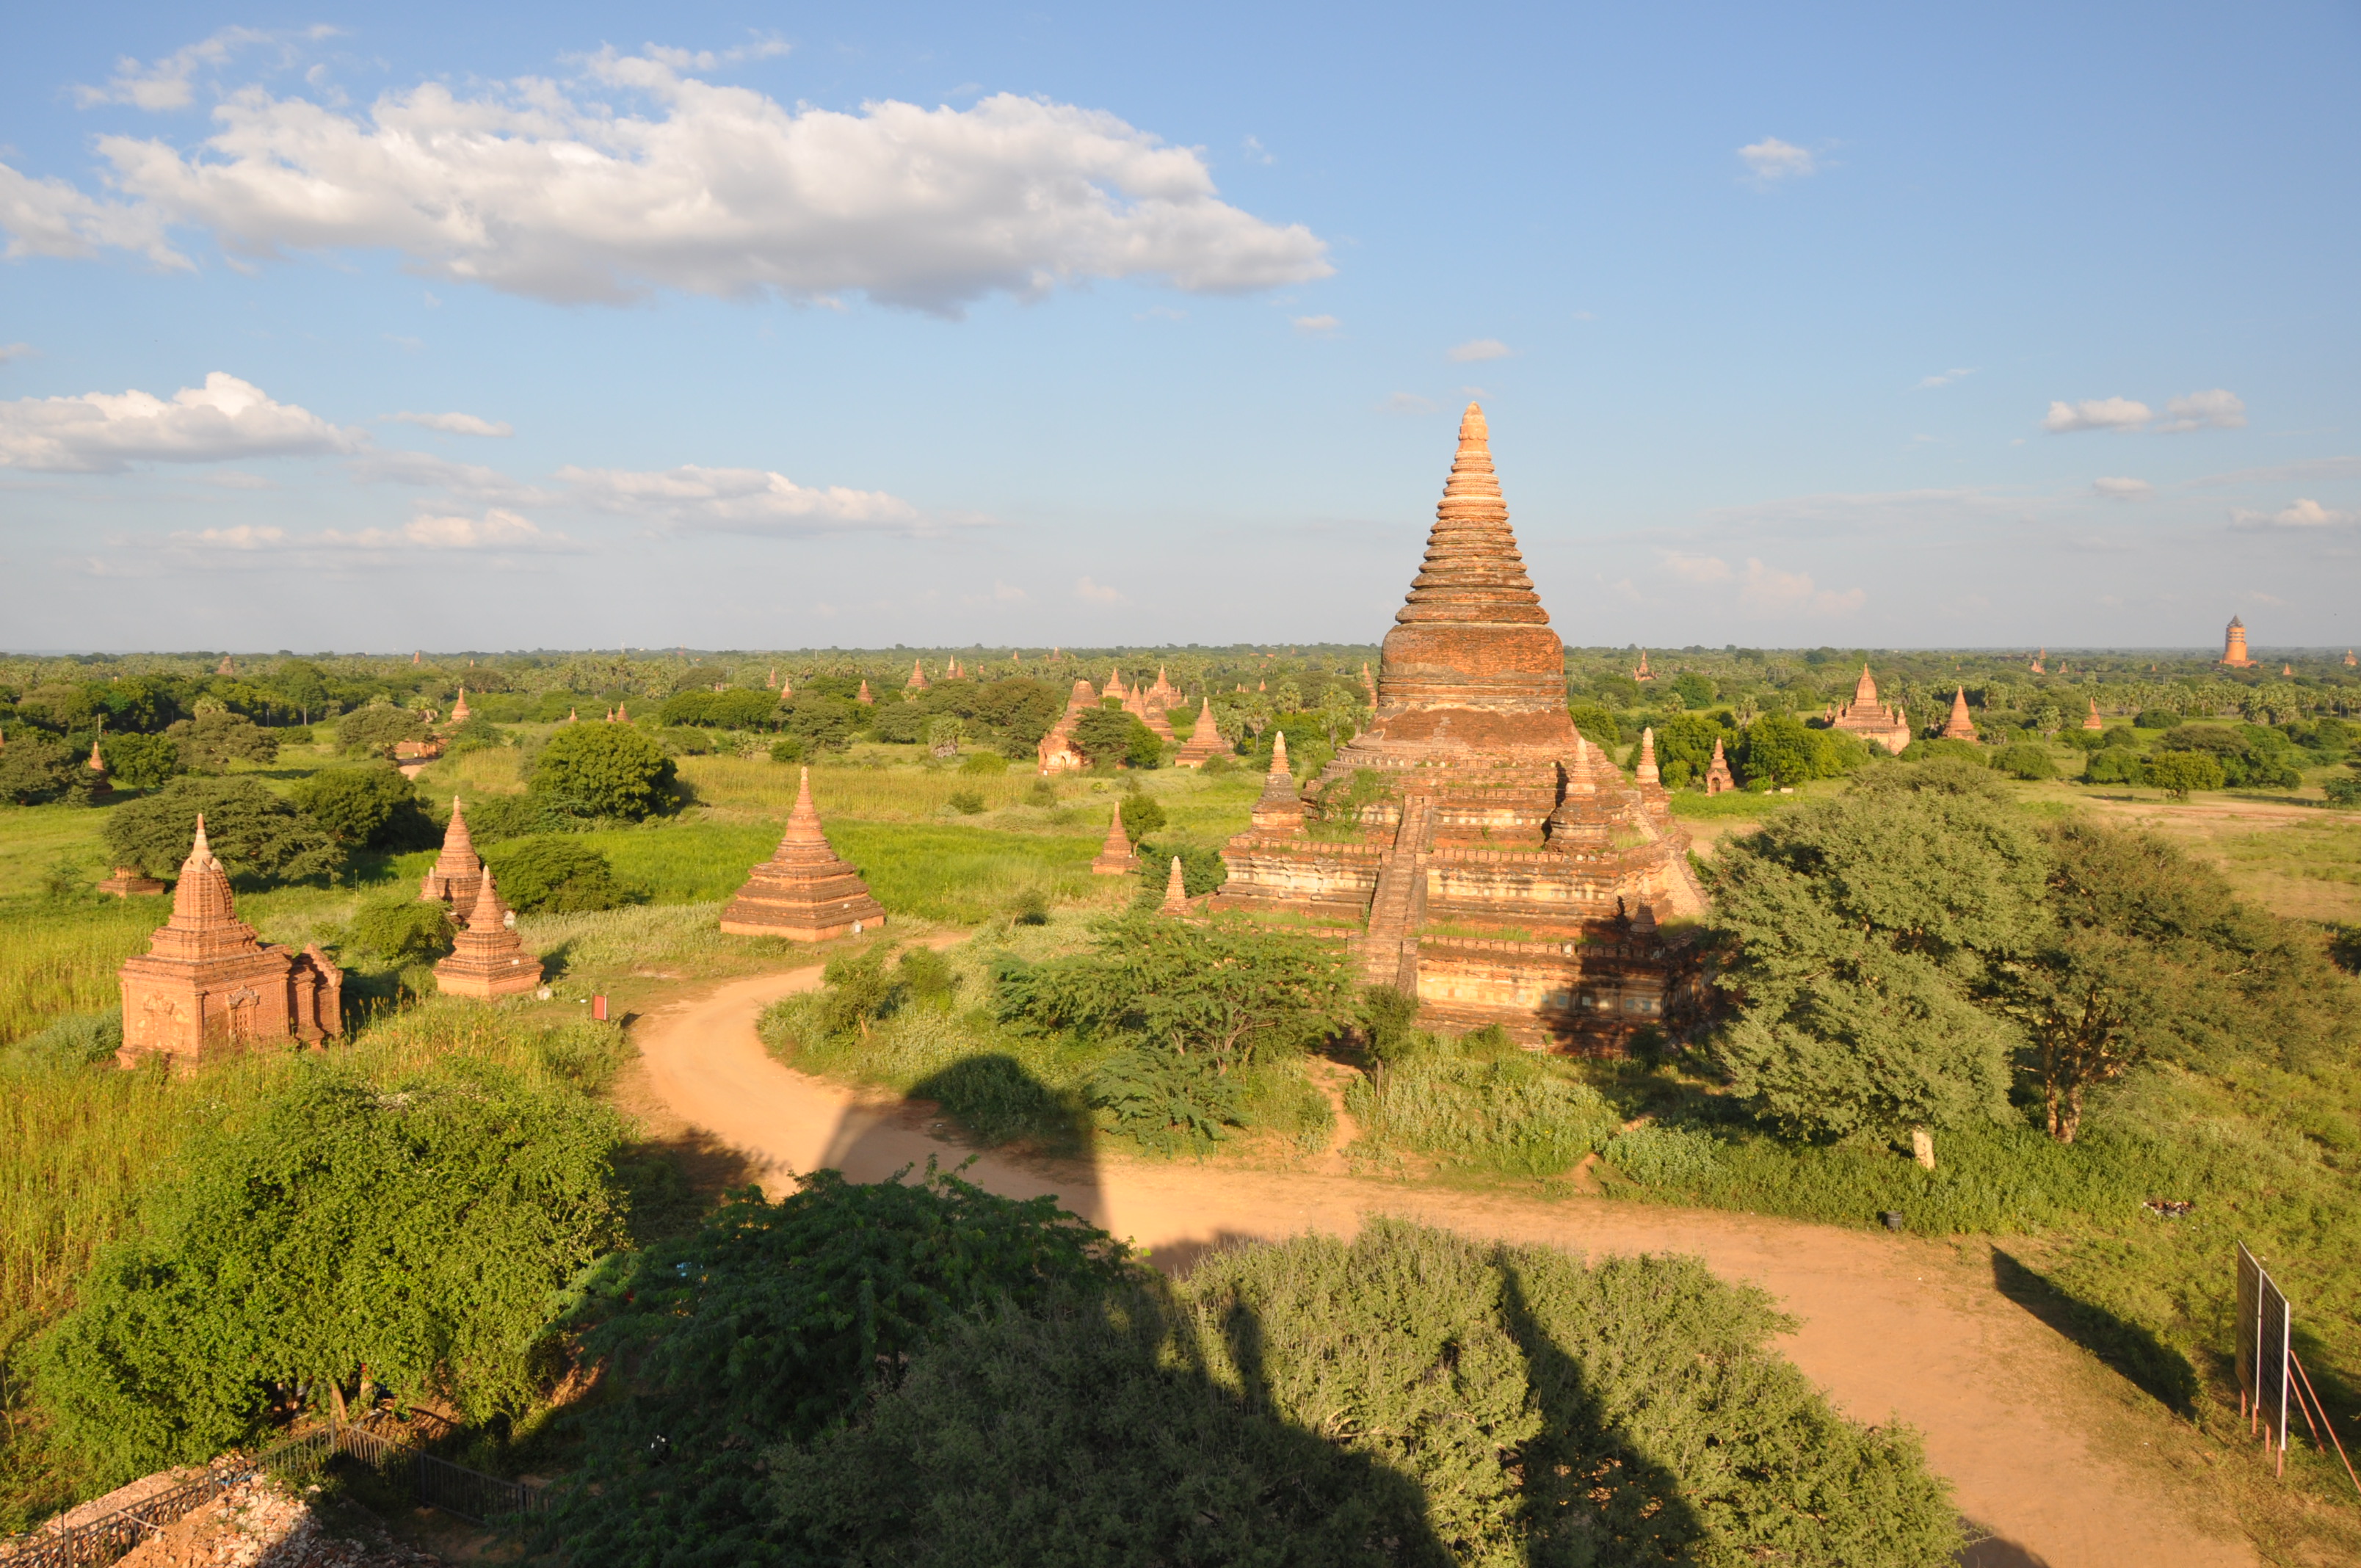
[116,817,345,1067]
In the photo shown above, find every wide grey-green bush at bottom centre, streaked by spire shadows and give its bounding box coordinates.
[769,1221,1957,1568]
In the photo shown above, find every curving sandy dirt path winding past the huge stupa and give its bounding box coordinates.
[635,963,2257,1568]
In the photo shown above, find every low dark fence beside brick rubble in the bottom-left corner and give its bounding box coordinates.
[0,1424,550,1568]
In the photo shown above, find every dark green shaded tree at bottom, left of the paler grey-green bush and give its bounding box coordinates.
[536,1169,1131,1568]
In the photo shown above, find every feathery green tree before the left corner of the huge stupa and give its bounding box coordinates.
[996,914,1360,1070]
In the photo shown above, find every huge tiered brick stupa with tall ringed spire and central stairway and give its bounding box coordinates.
[1214,404,1705,1051]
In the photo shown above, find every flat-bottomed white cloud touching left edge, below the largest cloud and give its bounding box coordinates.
[0,371,366,475]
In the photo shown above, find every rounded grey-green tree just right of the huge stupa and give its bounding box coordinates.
[1709,763,2047,1136]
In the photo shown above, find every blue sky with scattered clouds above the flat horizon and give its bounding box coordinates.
[0,2,2361,650]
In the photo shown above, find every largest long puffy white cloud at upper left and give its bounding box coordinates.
[23,50,1334,314]
